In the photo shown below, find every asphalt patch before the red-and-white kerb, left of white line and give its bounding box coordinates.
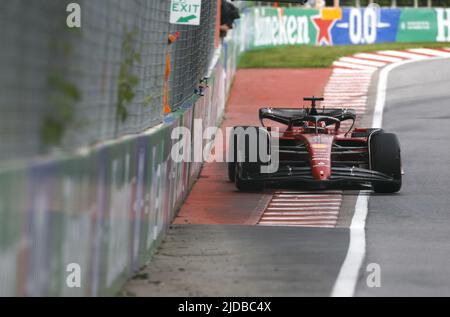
[124,225,348,297]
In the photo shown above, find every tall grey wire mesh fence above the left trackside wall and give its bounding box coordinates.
[0,0,221,161]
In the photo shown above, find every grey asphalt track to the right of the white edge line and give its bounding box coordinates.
[356,59,450,296]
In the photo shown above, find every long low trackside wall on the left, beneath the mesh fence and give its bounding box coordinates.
[0,43,226,296]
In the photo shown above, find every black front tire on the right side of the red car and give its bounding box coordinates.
[370,133,402,194]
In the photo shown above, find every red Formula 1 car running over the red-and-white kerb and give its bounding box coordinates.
[228,97,402,193]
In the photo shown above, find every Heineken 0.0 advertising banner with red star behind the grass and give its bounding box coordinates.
[243,7,450,49]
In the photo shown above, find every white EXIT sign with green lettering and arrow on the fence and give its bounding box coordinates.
[170,0,202,25]
